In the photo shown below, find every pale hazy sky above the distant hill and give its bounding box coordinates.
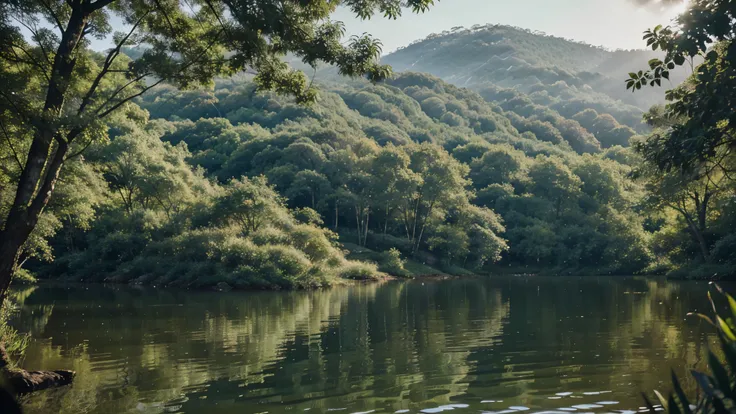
[335,0,679,53]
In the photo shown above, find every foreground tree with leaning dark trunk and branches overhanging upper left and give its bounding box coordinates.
[0,0,433,297]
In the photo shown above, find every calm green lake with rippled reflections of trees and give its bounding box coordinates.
[13,277,716,414]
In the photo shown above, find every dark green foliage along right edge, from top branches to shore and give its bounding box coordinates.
[626,0,736,278]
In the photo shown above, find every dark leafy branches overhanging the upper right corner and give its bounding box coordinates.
[626,0,736,171]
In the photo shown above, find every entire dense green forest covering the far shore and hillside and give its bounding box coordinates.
[3,26,733,289]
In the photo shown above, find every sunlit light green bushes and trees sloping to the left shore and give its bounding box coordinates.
[39,122,378,288]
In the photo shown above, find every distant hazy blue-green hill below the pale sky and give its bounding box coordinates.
[383,25,688,131]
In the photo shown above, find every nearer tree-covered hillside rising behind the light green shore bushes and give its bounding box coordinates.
[123,73,650,273]
